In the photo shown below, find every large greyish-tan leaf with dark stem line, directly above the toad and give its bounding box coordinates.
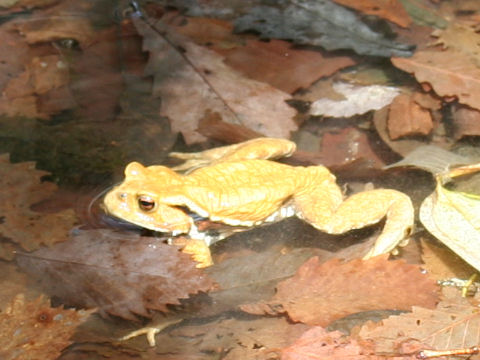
[134,15,297,144]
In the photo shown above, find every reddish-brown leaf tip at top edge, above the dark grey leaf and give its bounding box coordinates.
[334,0,412,27]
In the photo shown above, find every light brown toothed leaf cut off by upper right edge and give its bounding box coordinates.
[392,49,480,109]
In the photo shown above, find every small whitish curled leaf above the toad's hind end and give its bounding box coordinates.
[310,82,399,117]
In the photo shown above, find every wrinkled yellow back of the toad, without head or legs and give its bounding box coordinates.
[178,160,330,221]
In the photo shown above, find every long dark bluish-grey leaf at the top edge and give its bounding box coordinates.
[235,0,411,57]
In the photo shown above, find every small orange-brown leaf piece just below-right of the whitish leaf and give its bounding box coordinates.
[388,94,433,140]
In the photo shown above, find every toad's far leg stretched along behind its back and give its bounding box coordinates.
[169,138,296,172]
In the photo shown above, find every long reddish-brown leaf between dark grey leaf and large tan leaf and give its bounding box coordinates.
[171,16,355,94]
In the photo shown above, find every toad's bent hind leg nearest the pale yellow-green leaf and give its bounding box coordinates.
[295,183,414,259]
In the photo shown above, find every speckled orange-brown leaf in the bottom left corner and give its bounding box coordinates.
[0,295,93,360]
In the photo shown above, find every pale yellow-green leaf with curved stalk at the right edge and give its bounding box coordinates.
[420,164,480,270]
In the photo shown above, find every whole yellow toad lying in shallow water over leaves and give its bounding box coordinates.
[104,138,414,266]
